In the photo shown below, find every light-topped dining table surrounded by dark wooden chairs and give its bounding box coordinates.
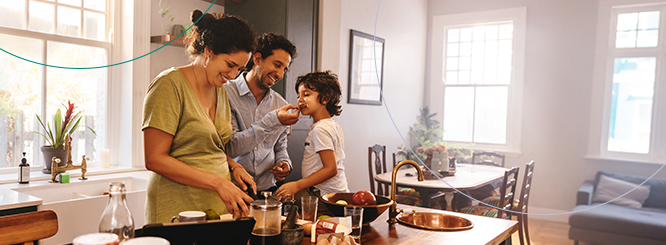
[375,164,508,211]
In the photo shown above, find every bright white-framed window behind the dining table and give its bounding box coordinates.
[431,8,525,152]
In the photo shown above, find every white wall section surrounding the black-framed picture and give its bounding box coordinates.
[319,0,428,191]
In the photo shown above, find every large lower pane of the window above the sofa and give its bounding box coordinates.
[608,57,656,154]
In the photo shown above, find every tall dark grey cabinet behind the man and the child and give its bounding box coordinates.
[224,0,319,181]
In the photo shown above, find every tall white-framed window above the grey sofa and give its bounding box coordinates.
[590,4,666,165]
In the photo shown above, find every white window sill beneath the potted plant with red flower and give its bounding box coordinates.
[0,167,146,184]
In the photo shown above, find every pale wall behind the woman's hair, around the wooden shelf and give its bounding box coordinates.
[150,0,224,79]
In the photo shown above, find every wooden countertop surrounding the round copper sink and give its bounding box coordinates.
[301,204,518,245]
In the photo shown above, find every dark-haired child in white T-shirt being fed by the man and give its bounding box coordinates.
[276,71,349,201]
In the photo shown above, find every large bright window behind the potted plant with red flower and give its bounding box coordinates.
[0,0,113,171]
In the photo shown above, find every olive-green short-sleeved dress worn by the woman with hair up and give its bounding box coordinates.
[141,68,232,223]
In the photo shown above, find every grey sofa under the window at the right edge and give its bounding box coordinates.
[569,171,666,245]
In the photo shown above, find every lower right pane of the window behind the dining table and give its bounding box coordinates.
[474,86,509,144]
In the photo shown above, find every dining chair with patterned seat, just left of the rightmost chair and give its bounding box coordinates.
[461,167,519,219]
